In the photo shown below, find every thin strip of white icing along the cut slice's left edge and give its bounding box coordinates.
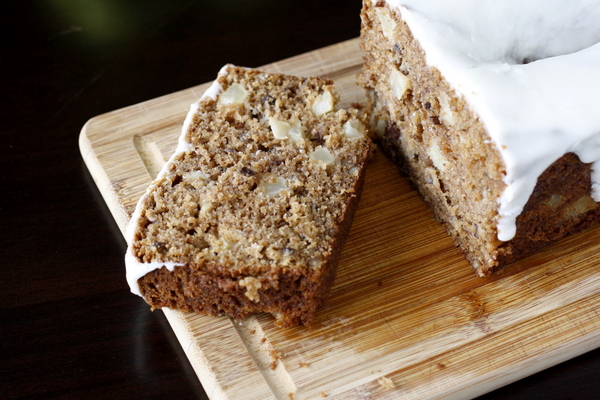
[125,65,229,296]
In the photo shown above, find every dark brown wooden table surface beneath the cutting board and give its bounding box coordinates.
[0,0,600,399]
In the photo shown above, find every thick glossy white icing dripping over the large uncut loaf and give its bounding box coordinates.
[387,0,600,241]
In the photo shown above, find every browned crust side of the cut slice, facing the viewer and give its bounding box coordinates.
[138,260,335,327]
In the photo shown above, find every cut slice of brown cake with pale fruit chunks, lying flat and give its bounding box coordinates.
[126,65,370,326]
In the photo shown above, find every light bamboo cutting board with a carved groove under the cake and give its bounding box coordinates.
[80,39,600,400]
